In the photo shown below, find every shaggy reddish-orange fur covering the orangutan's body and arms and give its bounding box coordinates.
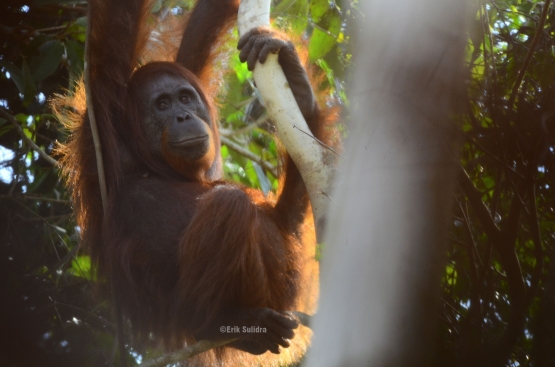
[52,0,335,366]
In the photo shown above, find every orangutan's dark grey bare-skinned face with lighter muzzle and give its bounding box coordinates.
[142,75,214,179]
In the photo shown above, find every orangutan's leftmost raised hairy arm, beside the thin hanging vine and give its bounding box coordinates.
[84,0,153,183]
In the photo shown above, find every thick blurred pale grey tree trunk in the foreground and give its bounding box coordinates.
[307,0,467,367]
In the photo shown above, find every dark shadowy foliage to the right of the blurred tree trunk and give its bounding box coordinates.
[438,0,555,366]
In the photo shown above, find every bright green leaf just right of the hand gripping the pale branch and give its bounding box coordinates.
[308,9,342,62]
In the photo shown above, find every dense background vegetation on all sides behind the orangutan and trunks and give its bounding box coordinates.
[0,0,555,366]
